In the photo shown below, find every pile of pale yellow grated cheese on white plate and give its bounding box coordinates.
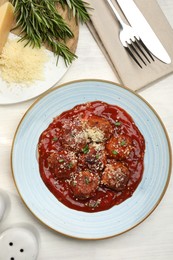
[0,39,48,84]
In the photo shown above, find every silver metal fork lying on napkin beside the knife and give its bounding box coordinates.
[106,0,154,68]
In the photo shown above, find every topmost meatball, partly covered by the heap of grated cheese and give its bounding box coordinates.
[86,115,113,142]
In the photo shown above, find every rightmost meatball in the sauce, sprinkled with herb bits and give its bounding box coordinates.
[106,135,133,160]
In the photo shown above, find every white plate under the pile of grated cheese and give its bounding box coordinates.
[0,33,69,105]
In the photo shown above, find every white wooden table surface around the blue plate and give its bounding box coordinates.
[0,0,173,260]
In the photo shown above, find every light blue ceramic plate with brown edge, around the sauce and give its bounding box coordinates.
[11,79,172,240]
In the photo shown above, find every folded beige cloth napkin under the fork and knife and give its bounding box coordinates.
[85,0,173,90]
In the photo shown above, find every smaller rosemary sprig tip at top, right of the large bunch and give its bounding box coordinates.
[59,0,92,24]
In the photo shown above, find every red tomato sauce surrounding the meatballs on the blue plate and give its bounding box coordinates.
[38,101,145,212]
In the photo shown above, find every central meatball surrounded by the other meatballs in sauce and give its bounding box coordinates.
[79,143,106,172]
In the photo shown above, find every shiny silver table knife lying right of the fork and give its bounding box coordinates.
[116,0,171,64]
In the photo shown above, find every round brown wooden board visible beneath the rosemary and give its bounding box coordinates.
[0,0,79,52]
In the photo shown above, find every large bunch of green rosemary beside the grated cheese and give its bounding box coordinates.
[11,0,82,65]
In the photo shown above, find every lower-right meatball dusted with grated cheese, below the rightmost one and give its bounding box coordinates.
[101,162,130,191]
